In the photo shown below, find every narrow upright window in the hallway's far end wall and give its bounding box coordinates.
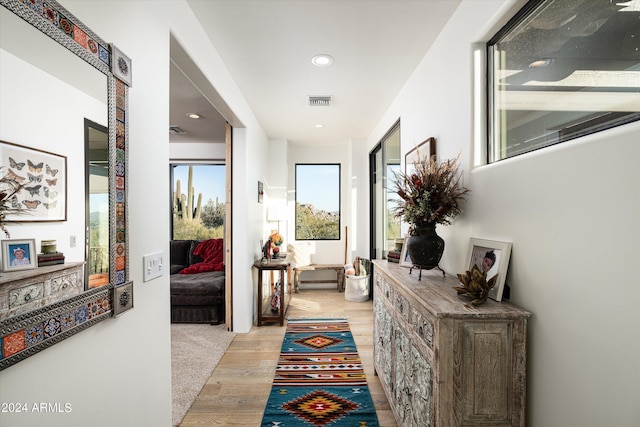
[296,164,340,240]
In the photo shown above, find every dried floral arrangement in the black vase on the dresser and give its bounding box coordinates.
[389,152,469,235]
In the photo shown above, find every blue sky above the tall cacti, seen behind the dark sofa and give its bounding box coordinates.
[173,165,225,206]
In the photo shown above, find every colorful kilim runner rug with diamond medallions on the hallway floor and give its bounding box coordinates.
[261,319,378,427]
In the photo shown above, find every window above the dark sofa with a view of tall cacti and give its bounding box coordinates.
[171,164,226,240]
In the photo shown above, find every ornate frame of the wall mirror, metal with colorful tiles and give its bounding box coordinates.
[0,0,133,370]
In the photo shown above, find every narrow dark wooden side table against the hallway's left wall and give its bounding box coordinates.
[253,258,291,326]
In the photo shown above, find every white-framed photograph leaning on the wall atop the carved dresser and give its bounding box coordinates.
[467,238,511,301]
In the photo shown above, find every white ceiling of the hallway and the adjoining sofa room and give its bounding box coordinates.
[171,0,459,145]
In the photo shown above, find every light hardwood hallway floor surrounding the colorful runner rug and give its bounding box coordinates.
[180,289,397,427]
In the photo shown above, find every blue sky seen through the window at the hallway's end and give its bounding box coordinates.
[296,165,340,212]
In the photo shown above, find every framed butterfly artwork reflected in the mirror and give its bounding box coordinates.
[0,141,67,222]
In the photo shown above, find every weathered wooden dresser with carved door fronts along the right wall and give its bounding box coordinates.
[373,260,531,427]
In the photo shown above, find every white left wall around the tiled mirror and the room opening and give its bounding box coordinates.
[0,0,267,427]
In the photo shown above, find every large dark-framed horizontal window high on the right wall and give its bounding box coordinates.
[487,0,640,162]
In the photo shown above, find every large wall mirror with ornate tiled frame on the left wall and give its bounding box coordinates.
[0,0,133,370]
